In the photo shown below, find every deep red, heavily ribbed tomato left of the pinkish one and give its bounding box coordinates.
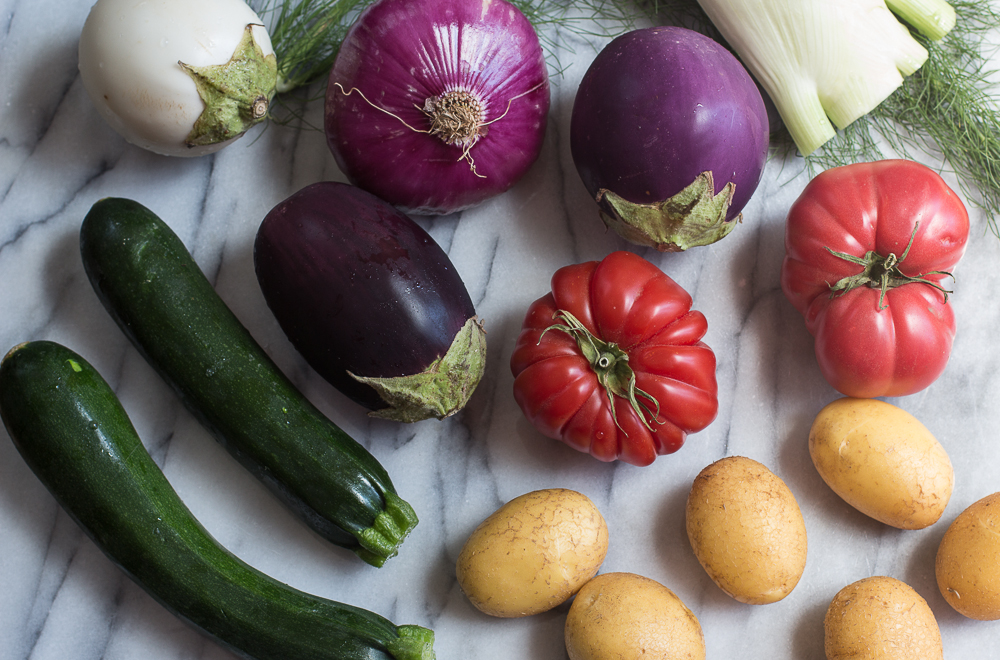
[510,252,719,465]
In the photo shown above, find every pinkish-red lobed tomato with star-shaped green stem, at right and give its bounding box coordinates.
[781,160,969,398]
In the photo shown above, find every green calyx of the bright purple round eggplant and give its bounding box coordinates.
[596,172,742,252]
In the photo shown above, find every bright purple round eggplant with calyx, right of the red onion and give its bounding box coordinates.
[570,27,769,251]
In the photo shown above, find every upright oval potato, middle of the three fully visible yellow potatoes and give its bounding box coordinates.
[686,456,807,605]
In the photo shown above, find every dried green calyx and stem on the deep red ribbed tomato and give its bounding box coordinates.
[538,310,663,432]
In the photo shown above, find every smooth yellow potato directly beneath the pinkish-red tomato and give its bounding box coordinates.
[809,398,955,529]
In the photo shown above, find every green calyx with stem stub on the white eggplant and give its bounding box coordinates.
[177,24,278,147]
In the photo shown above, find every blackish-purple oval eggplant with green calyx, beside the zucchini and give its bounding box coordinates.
[254,182,486,422]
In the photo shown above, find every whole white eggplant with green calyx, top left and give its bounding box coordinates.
[79,0,277,156]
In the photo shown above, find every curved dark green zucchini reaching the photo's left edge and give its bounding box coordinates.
[0,341,434,660]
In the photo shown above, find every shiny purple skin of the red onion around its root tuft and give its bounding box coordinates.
[325,0,549,215]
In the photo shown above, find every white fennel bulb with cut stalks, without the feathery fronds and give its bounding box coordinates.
[698,0,955,156]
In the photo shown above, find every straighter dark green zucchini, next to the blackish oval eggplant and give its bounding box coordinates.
[80,198,417,566]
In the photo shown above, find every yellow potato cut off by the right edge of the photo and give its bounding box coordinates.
[934,493,1000,621]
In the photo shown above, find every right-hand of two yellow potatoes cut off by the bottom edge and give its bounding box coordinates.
[823,576,944,660]
